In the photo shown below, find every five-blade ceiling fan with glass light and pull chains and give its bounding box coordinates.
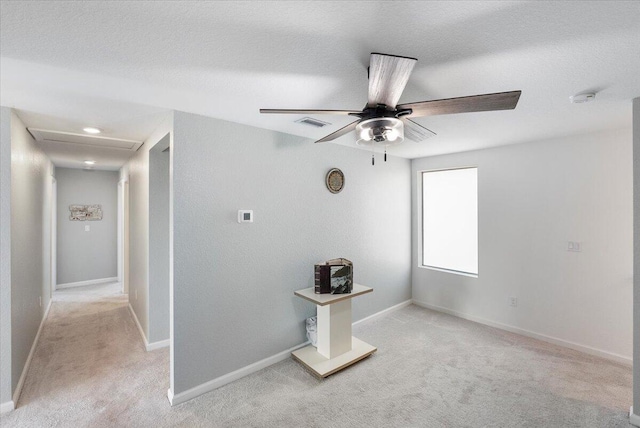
[260,53,521,163]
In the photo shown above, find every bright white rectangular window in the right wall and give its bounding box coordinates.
[422,168,478,275]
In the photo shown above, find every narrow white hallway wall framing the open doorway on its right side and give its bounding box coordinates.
[120,113,173,342]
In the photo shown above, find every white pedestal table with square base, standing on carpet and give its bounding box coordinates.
[292,284,378,378]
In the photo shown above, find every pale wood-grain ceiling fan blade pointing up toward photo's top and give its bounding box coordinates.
[367,53,418,108]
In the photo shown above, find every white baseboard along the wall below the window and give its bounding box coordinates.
[413,300,633,366]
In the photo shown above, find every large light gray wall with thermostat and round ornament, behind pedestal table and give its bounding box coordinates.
[171,112,411,394]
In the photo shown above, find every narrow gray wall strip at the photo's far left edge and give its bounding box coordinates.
[0,107,12,404]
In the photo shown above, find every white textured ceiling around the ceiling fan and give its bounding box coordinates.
[0,1,640,168]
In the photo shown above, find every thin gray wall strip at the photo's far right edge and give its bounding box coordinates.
[633,98,640,415]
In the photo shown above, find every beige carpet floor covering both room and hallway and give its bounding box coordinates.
[0,285,632,428]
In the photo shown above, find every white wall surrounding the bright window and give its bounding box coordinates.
[412,130,633,362]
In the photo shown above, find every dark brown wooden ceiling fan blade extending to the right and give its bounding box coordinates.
[397,91,521,117]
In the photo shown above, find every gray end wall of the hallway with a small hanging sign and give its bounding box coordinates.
[56,168,118,286]
